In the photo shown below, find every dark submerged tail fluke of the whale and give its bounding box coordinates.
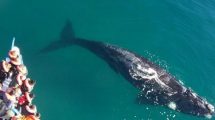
[39,20,76,53]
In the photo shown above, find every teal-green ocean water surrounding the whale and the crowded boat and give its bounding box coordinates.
[0,0,215,120]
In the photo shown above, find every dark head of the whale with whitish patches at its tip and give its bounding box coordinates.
[175,89,214,118]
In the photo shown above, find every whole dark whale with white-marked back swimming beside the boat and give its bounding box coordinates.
[39,20,214,117]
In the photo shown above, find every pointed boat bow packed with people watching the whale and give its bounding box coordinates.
[0,38,40,120]
